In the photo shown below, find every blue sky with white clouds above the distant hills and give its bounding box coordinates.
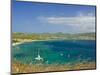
[12,1,96,33]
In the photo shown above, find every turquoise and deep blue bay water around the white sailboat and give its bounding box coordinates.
[12,40,96,64]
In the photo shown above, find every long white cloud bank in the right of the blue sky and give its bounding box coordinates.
[38,13,95,32]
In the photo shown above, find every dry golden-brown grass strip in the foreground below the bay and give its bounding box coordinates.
[12,62,96,73]
